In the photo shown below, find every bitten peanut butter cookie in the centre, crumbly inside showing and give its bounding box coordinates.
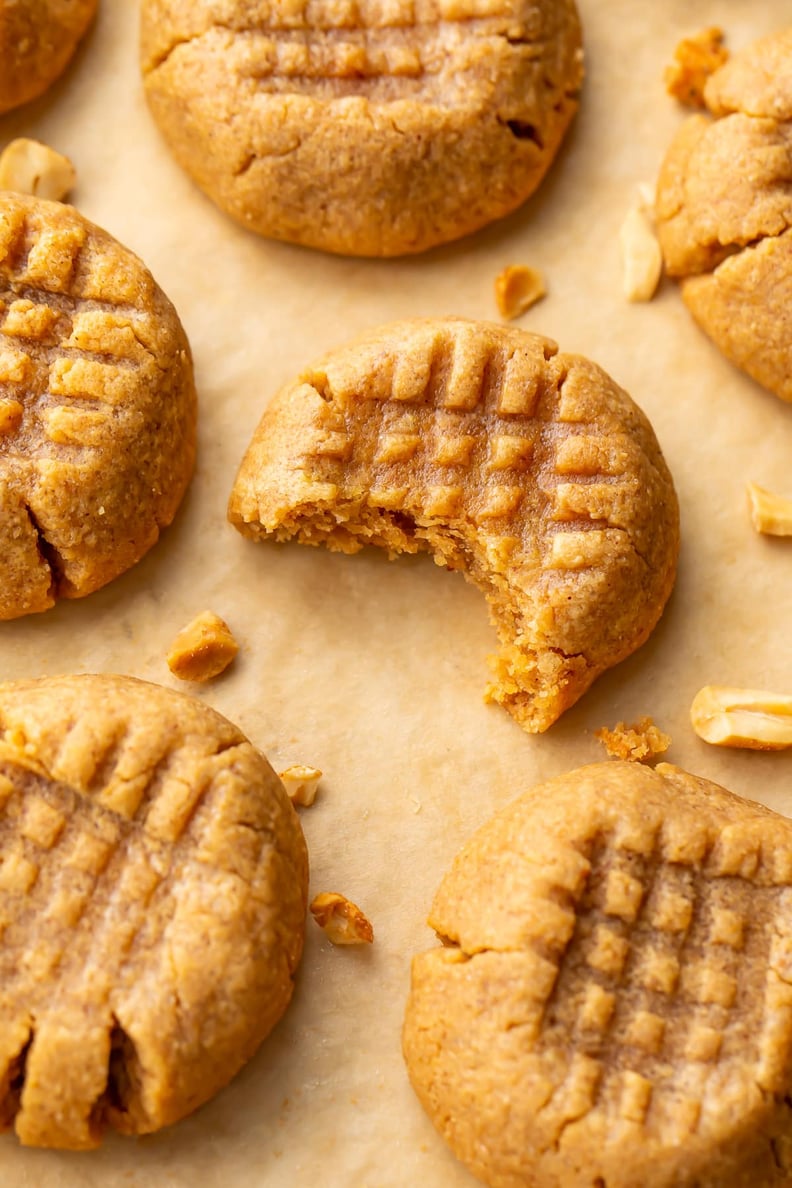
[229,318,678,731]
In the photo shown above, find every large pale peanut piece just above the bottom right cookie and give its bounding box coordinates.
[690,684,792,751]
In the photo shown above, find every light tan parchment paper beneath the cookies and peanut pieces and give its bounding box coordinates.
[0,0,792,1188]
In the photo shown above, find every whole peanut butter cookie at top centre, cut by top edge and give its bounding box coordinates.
[142,0,583,255]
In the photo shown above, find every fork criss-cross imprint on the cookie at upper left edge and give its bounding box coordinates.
[0,201,157,462]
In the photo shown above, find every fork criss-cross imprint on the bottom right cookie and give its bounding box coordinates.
[520,835,792,1142]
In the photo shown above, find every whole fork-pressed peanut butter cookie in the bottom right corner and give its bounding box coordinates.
[404,763,792,1188]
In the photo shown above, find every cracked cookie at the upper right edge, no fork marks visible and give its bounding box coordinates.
[657,29,792,400]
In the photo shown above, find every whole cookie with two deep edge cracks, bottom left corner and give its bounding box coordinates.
[0,676,308,1149]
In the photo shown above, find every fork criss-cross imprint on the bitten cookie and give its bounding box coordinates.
[294,324,646,569]
